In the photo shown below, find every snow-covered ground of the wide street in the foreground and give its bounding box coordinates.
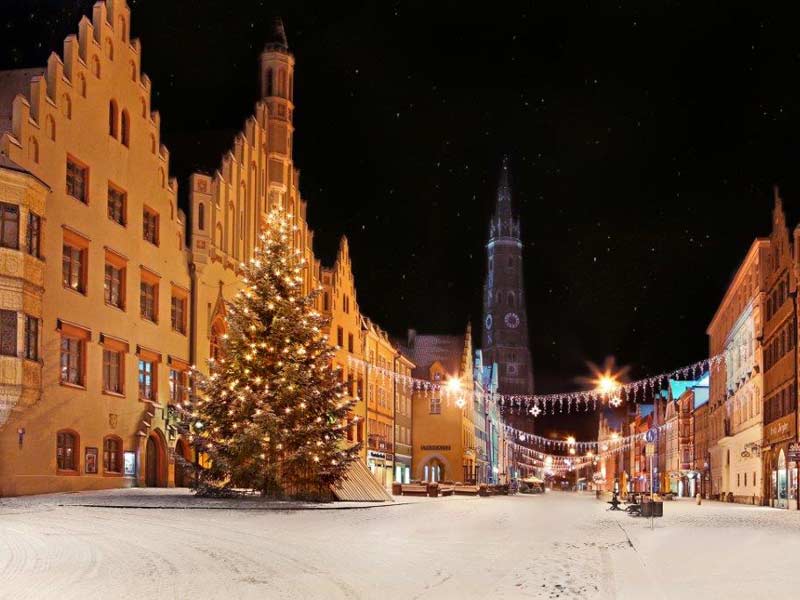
[0,490,800,600]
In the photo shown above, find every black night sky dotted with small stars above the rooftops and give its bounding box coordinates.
[0,0,800,436]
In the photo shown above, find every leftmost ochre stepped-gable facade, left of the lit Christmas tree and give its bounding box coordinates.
[0,0,191,495]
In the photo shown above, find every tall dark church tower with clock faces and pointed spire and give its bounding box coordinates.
[483,157,533,394]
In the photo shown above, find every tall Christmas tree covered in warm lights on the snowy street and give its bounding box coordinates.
[189,210,358,497]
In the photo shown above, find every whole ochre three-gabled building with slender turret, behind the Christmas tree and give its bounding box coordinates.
[0,0,400,496]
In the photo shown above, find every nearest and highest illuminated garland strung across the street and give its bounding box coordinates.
[347,354,724,417]
